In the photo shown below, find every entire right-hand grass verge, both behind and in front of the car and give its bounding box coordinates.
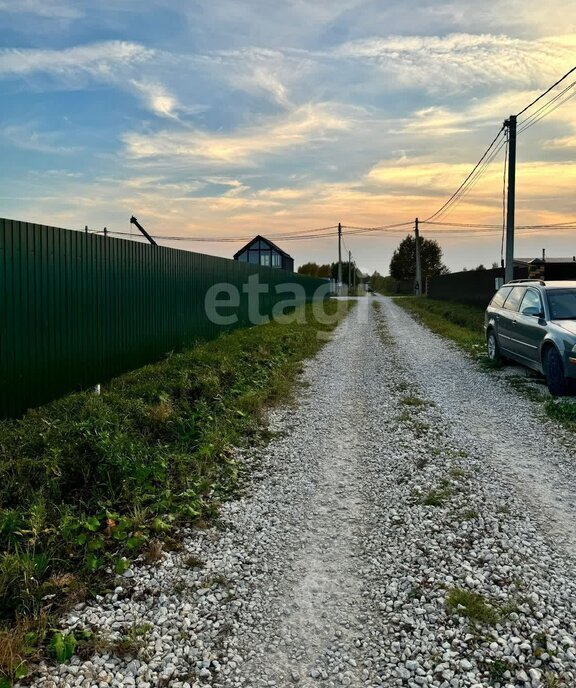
[394,296,576,431]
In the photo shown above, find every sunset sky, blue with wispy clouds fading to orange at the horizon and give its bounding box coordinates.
[0,0,576,274]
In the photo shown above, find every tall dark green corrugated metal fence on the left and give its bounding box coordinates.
[0,219,325,417]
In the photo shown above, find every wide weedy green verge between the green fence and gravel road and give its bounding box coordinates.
[0,301,351,688]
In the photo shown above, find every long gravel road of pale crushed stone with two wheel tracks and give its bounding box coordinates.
[31,297,576,688]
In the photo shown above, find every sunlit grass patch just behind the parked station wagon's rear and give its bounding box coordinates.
[394,296,486,356]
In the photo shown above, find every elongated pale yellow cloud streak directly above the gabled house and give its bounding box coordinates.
[123,103,351,167]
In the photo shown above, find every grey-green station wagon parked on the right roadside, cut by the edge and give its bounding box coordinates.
[484,280,576,396]
